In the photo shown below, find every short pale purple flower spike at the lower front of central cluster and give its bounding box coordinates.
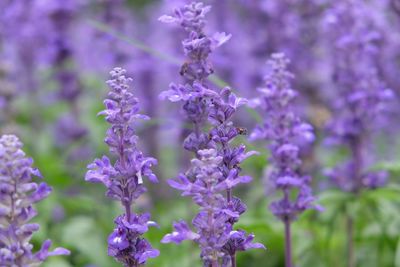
[162,149,231,262]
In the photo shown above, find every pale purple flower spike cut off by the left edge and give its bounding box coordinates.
[0,135,69,267]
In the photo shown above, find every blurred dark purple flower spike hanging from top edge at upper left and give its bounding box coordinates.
[38,0,90,162]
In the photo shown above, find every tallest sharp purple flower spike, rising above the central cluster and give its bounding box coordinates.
[159,3,230,155]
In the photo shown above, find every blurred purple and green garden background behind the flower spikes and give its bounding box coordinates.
[0,0,400,267]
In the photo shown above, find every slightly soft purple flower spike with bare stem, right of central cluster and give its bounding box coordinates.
[251,53,319,267]
